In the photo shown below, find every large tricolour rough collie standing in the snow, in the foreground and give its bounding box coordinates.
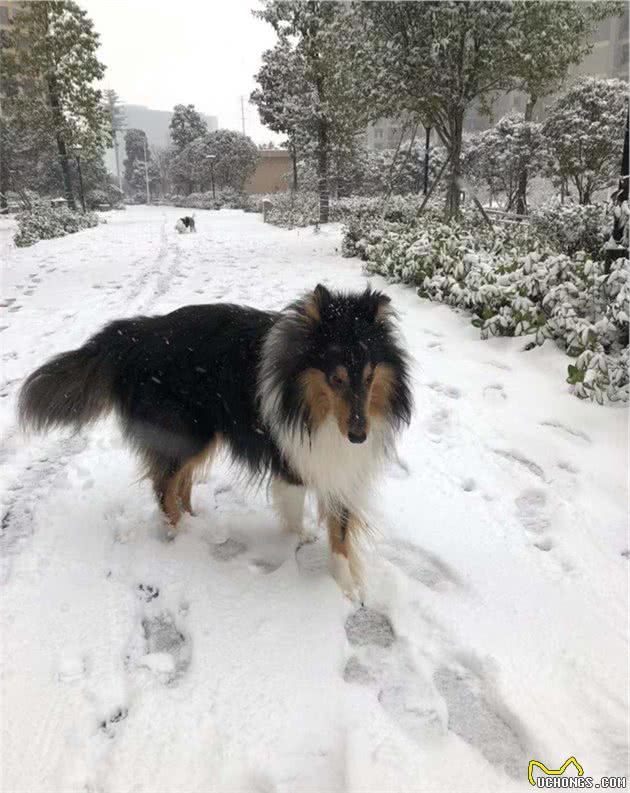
[19,285,412,592]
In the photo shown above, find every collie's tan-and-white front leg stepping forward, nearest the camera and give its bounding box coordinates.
[326,504,363,599]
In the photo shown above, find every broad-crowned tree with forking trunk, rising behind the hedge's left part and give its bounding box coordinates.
[347,0,524,216]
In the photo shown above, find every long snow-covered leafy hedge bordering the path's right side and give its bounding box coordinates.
[344,215,630,403]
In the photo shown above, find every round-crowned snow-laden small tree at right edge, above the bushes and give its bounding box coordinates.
[543,77,628,204]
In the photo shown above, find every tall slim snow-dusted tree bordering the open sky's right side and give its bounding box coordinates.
[254,0,366,223]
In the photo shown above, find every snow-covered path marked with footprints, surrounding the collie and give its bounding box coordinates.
[0,208,629,793]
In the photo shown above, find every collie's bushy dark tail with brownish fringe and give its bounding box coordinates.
[18,338,114,432]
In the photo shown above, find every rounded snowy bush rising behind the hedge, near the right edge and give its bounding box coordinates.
[529,202,613,259]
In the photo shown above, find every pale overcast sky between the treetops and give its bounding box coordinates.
[79,0,282,143]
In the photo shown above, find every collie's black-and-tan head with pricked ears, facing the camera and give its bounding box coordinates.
[263,284,411,443]
